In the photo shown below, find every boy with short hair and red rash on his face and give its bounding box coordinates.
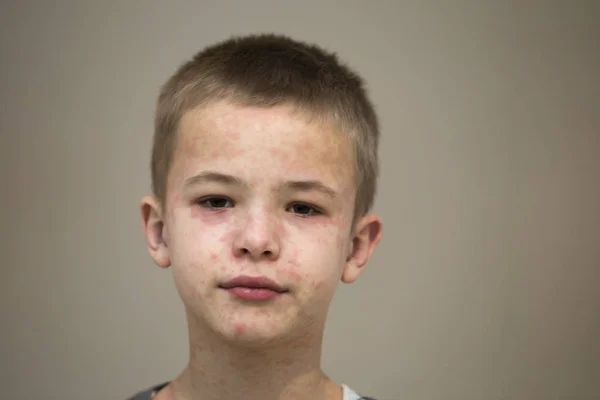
[133,35,382,400]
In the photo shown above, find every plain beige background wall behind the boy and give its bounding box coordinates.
[0,0,600,400]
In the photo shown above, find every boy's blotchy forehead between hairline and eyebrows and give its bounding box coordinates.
[172,101,354,192]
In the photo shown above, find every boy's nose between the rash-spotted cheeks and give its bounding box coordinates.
[233,210,281,261]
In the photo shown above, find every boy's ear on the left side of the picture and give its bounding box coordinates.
[140,196,171,268]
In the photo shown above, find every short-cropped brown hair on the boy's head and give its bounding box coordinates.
[151,34,379,217]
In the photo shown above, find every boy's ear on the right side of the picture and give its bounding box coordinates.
[342,215,383,283]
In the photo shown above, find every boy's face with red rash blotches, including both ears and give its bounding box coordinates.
[142,102,381,344]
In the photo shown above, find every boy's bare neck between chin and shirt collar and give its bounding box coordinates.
[169,315,341,400]
